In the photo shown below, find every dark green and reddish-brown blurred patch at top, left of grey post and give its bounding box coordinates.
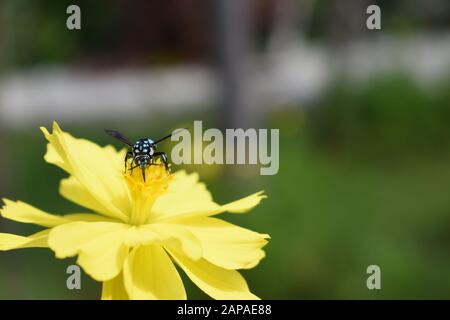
[0,0,211,67]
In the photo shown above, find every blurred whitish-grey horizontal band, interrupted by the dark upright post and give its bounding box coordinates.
[0,34,450,126]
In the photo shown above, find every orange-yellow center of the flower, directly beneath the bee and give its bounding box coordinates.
[124,163,172,225]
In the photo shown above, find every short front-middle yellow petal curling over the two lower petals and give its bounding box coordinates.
[125,223,202,260]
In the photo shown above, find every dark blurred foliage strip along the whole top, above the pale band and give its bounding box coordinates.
[0,0,450,68]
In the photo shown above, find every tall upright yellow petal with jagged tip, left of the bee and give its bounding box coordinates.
[41,122,131,221]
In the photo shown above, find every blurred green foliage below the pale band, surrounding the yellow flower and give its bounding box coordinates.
[0,75,450,299]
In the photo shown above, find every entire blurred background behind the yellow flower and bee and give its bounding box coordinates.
[0,0,450,299]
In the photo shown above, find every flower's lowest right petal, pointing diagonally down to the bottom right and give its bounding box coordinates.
[169,250,259,300]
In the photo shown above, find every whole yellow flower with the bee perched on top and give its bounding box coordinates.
[0,123,269,299]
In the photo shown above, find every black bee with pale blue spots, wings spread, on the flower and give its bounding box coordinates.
[105,129,184,181]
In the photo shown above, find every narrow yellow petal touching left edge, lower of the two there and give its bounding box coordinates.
[0,229,50,251]
